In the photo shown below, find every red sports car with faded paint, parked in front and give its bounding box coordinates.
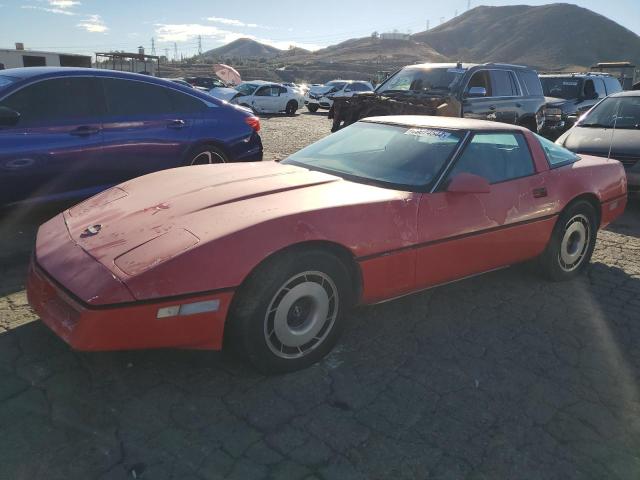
[28,116,627,372]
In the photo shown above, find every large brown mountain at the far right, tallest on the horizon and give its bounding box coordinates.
[412,3,640,69]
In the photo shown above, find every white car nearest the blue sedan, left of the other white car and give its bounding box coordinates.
[219,80,304,115]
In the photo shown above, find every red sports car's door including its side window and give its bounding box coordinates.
[416,132,554,288]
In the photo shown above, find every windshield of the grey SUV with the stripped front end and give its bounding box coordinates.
[376,68,464,93]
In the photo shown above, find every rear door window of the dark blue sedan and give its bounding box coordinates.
[102,78,173,116]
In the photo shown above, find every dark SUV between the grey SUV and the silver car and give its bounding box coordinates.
[540,73,622,140]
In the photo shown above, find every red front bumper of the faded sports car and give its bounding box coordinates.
[27,260,233,351]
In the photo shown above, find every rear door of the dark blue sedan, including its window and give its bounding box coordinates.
[102,77,196,185]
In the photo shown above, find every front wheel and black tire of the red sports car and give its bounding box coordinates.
[226,250,353,374]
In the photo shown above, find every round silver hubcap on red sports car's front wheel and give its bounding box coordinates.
[264,271,338,359]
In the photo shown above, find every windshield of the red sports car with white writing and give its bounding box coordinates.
[283,122,464,189]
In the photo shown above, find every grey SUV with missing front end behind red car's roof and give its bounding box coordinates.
[329,63,545,132]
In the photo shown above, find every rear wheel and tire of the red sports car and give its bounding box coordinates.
[538,200,598,282]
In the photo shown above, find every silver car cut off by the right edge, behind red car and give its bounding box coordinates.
[556,90,640,194]
